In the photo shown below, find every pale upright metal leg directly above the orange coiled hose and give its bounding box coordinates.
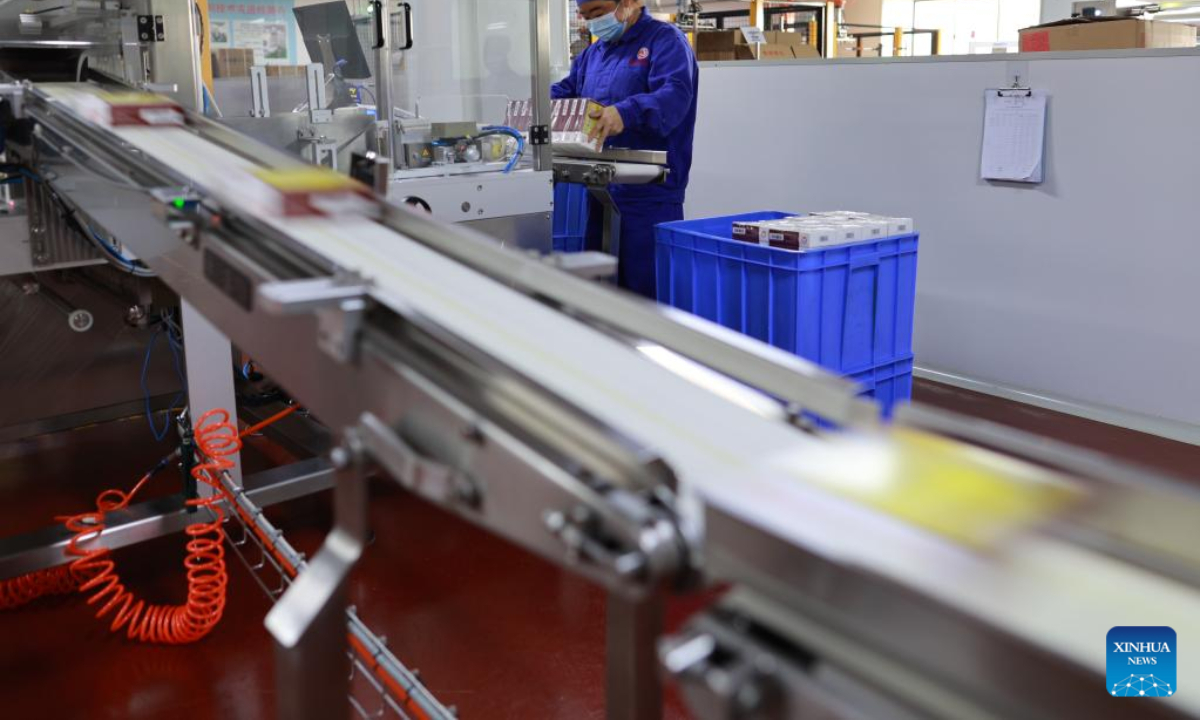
[182,300,242,484]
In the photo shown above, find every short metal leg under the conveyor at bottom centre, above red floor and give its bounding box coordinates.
[606,593,664,720]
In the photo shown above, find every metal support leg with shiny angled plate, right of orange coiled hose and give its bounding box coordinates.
[265,433,367,720]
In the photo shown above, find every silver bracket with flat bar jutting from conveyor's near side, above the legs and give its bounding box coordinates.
[258,276,367,362]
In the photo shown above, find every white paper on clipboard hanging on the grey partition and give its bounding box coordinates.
[980,90,1046,182]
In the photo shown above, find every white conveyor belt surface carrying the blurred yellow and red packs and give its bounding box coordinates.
[56,98,1200,713]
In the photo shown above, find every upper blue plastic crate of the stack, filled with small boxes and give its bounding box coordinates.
[655,211,919,374]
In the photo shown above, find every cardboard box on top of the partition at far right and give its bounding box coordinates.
[1021,18,1196,53]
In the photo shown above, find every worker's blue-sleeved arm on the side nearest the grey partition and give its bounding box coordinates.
[613,31,696,136]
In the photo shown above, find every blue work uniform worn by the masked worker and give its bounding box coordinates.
[550,10,700,299]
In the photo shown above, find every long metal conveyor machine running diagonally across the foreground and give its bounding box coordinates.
[0,0,1200,720]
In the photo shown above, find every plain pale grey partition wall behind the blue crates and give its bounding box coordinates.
[688,50,1200,442]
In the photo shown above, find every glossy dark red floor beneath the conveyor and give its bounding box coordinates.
[0,383,1200,720]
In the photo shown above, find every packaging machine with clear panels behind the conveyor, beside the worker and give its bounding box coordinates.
[199,0,666,254]
